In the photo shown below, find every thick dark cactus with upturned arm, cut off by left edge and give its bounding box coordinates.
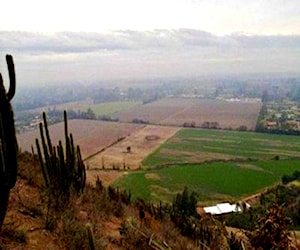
[0,55,18,230]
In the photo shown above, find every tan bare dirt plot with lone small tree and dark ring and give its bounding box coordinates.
[85,125,180,185]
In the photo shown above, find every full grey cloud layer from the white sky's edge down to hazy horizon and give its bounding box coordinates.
[0,29,300,84]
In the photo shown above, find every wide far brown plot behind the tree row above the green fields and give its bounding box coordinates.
[115,98,261,129]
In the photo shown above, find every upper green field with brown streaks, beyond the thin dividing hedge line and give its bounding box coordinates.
[143,129,300,167]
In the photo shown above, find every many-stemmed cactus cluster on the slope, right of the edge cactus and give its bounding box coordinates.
[36,111,86,209]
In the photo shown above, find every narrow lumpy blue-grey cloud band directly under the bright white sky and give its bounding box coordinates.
[0,29,300,53]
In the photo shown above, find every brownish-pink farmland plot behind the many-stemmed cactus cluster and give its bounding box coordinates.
[17,120,142,158]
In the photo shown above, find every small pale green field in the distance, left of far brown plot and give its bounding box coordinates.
[80,101,141,116]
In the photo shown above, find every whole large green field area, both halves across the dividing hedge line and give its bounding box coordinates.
[114,129,300,203]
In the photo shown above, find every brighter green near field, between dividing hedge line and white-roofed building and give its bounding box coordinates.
[114,160,300,202]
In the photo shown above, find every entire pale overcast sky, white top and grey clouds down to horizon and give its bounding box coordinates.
[0,0,300,84]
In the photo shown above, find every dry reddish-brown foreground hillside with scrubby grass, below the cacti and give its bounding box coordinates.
[0,153,199,249]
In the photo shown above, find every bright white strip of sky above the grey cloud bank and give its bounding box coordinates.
[0,0,300,35]
